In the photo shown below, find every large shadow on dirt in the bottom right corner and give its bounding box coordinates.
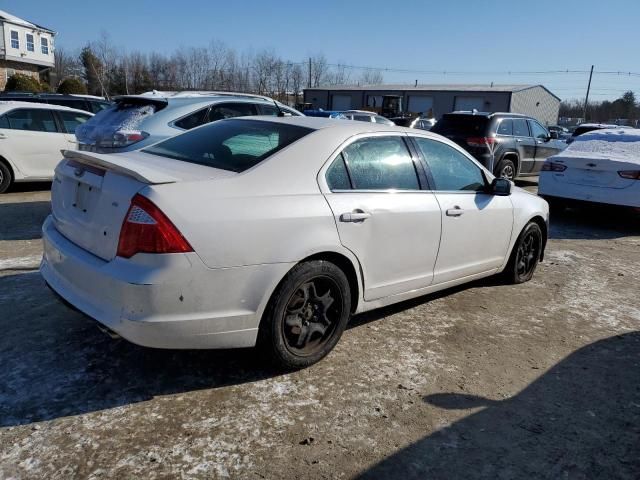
[360,332,640,479]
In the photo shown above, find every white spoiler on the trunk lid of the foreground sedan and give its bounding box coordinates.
[61,150,180,185]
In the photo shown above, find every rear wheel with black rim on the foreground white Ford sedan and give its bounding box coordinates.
[258,260,351,370]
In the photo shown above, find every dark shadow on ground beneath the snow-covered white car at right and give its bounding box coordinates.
[549,204,640,240]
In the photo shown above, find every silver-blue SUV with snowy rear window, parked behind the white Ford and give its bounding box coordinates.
[76,91,302,153]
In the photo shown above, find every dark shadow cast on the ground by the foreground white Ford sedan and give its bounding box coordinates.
[0,271,510,427]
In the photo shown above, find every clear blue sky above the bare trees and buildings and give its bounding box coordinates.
[0,0,640,100]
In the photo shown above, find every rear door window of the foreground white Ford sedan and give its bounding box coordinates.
[342,136,420,190]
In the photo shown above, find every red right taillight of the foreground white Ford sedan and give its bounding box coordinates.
[117,195,193,258]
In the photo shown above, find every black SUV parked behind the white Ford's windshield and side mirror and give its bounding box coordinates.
[431,112,567,180]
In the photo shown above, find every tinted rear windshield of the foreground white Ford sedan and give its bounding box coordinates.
[142,120,312,172]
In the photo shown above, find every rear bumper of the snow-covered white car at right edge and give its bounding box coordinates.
[538,172,640,208]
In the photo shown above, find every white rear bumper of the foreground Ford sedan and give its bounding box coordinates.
[40,217,291,348]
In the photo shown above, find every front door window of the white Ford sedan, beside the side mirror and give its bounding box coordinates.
[415,137,485,192]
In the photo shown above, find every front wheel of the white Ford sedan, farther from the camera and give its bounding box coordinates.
[505,222,543,284]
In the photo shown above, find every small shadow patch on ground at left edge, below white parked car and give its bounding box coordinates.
[0,202,51,241]
